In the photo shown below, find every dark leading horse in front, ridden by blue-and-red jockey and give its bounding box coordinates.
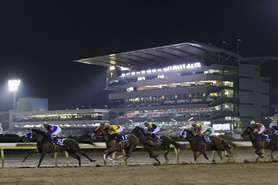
[23,129,95,168]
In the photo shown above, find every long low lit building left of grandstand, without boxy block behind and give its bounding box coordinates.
[9,109,109,135]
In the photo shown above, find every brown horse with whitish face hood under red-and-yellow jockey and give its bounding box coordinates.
[182,129,237,164]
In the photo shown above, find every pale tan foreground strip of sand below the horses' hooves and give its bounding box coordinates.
[0,163,278,185]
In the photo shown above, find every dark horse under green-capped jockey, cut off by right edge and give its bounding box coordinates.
[241,126,278,162]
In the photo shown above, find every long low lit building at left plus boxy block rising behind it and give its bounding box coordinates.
[8,98,109,136]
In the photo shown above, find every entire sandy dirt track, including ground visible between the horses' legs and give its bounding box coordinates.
[0,150,278,185]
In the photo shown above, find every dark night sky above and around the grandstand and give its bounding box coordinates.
[0,0,278,111]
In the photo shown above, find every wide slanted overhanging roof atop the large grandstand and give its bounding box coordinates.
[74,42,278,69]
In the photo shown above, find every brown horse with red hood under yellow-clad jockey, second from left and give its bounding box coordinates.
[92,125,139,165]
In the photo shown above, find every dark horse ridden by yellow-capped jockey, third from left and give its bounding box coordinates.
[129,126,181,164]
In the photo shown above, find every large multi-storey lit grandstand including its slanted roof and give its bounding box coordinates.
[76,42,269,131]
